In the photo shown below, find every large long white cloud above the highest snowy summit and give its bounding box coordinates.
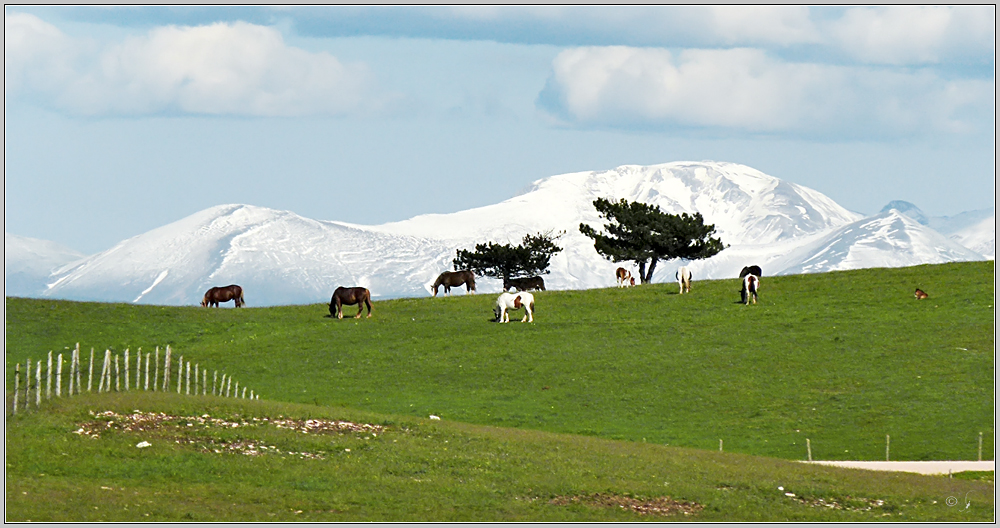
[539,46,992,137]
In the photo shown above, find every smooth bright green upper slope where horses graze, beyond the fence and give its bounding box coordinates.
[7,262,994,460]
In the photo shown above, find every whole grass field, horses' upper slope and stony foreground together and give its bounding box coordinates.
[6,262,995,520]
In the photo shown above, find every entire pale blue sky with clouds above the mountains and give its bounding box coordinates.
[4,5,996,254]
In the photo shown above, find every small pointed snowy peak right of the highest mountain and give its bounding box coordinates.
[776,209,983,275]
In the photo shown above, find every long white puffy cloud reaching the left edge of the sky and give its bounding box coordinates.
[4,14,378,116]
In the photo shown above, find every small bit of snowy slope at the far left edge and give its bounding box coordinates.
[3,233,86,297]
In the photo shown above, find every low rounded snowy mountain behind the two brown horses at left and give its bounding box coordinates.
[45,205,458,306]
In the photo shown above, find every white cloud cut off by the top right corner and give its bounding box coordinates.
[826,5,996,64]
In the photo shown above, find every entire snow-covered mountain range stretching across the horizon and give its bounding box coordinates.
[5,162,996,306]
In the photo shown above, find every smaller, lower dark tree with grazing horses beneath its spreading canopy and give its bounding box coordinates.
[453,232,562,281]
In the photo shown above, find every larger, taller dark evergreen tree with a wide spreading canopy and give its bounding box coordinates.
[580,198,725,283]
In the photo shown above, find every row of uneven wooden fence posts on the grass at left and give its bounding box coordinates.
[13,343,260,414]
